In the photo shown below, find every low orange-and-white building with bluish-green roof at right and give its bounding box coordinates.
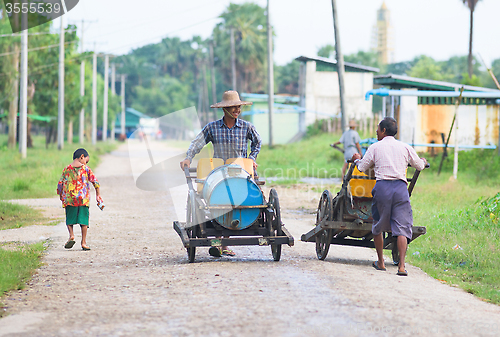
[374,74,500,151]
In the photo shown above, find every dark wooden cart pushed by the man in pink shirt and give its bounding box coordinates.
[301,163,429,264]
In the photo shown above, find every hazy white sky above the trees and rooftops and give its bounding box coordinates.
[63,0,500,65]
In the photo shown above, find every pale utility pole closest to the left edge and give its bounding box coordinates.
[19,13,28,159]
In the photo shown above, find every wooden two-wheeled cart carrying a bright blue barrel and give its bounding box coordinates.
[174,165,294,263]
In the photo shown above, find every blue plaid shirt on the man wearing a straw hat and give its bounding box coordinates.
[186,118,262,161]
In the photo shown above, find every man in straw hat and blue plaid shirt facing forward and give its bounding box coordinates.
[180,90,262,256]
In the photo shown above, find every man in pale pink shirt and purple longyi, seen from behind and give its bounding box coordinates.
[352,117,427,276]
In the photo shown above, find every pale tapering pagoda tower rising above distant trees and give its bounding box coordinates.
[371,1,395,65]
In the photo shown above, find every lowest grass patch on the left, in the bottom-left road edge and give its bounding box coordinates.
[0,242,45,317]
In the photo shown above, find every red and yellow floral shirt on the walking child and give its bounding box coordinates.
[57,165,100,207]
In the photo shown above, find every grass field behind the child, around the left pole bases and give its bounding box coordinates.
[0,135,117,200]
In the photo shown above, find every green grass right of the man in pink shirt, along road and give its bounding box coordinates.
[407,171,500,304]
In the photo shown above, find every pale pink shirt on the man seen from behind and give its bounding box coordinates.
[357,136,425,182]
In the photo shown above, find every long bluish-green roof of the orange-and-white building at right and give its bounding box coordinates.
[373,74,498,92]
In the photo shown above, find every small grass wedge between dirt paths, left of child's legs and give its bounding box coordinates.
[0,201,49,230]
